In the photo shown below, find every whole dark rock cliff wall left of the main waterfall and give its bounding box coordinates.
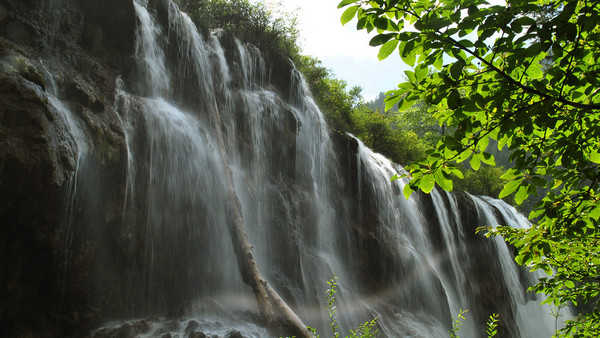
[0,0,135,337]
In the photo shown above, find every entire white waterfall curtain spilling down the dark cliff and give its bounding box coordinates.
[18,0,554,337]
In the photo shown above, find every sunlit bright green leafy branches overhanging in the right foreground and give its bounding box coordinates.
[339,0,600,336]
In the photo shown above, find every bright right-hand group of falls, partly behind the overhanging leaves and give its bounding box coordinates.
[350,140,568,337]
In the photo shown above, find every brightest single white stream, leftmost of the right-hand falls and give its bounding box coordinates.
[357,140,466,337]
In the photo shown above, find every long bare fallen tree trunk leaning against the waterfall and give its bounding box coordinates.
[214,110,312,337]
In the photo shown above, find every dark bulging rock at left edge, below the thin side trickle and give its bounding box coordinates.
[0,60,74,336]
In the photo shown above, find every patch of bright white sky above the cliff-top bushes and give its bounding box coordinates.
[265,0,409,100]
